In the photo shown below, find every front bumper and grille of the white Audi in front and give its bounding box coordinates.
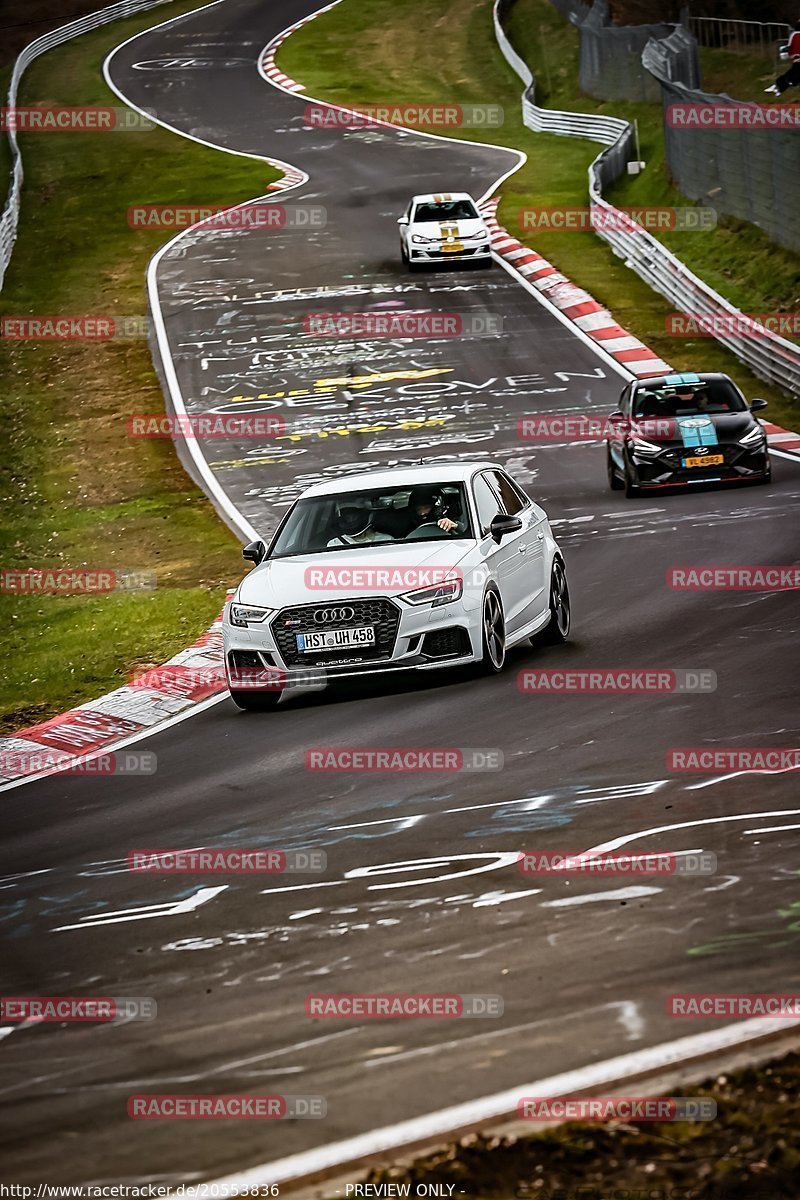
[222,596,482,691]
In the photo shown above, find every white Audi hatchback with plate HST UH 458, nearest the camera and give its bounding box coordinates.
[223,460,570,709]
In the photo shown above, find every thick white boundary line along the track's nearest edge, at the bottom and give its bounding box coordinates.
[210,1018,800,1189]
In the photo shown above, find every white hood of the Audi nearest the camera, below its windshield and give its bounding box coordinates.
[237,539,475,608]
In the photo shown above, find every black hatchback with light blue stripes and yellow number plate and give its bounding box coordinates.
[606,373,770,496]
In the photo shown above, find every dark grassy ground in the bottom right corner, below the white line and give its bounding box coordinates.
[352,1054,800,1200]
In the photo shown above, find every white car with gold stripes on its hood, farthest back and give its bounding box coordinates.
[397,192,492,270]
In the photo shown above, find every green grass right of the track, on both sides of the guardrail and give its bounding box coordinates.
[278,0,800,427]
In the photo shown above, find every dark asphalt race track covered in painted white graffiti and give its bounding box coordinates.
[0,0,800,1183]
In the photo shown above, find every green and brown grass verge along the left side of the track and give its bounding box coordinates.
[0,0,278,731]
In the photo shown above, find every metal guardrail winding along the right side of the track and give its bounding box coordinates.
[494,0,800,395]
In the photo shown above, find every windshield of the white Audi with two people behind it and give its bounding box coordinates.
[269,482,473,558]
